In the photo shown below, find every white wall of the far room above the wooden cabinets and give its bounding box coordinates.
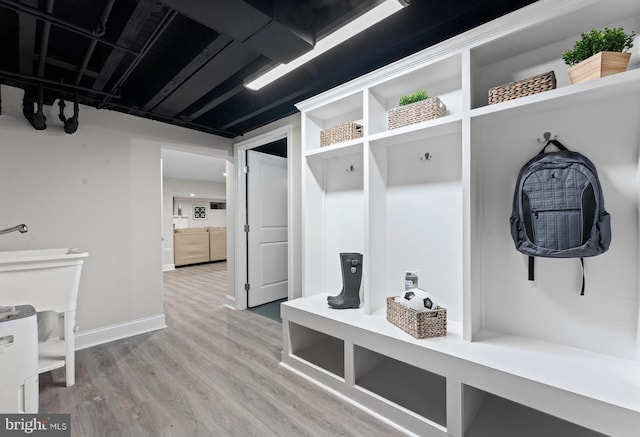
[162,178,227,270]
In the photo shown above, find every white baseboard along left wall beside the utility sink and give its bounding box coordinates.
[76,314,167,350]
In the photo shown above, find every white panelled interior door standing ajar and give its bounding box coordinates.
[247,150,288,308]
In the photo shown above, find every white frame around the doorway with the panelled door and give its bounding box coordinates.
[233,124,293,310]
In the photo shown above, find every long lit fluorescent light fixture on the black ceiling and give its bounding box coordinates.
[244,0,408,90]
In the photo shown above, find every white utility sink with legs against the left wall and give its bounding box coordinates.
[0,248,89,386]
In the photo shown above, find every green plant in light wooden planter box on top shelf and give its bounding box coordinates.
[562,27,636,83]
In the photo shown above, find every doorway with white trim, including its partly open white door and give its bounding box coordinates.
[234,126,292,312]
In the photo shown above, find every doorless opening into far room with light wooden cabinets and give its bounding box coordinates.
[161,148,231,322]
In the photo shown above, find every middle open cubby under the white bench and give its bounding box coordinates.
[354,346,447,427]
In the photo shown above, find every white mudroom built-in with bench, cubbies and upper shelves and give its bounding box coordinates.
[282,0,640,437]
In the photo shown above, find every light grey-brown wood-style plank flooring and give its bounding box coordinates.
[40,262,399,437]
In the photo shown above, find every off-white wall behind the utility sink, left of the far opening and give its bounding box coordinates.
[0,86,231,343]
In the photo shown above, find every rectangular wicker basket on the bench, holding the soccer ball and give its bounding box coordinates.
[387,297,447,338]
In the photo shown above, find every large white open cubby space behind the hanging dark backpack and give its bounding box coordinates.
[464,95,640,359]
